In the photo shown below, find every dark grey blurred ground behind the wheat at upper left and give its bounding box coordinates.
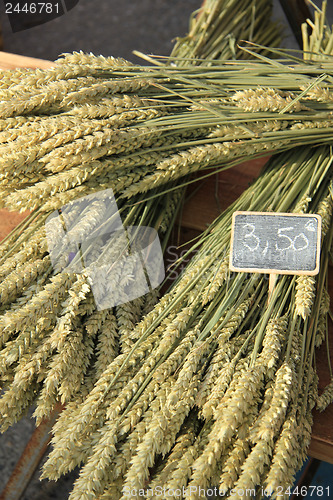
[0,0,201,60]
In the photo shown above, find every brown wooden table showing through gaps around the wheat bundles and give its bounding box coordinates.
[0,52,333,464]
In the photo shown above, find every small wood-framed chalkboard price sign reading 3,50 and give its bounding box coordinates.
[229,211,321,276]
